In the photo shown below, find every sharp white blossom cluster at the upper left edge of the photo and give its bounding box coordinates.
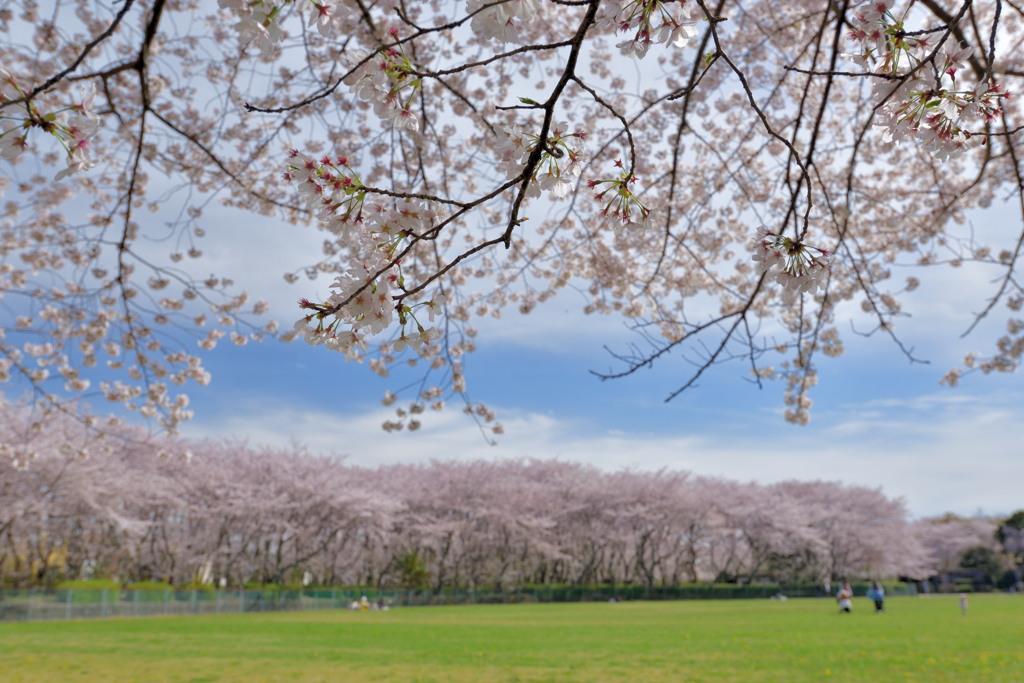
[0,71,100,180]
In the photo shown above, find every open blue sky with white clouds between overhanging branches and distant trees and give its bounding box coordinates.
[163,197,1024,515]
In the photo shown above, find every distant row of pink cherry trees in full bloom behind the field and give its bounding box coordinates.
[0,409,994,589]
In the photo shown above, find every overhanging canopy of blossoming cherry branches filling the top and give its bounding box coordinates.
[0,0,1024,433]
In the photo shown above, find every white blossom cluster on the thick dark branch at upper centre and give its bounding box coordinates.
[496,122,587,199]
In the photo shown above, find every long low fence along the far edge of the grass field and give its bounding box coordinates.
[0,584,918,622]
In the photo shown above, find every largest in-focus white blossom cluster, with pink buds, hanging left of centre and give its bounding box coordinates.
[285,150,446,359]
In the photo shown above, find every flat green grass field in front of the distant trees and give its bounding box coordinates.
[0,595,1024,683]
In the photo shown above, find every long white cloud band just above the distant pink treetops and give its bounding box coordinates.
[187,387,1024,515]
